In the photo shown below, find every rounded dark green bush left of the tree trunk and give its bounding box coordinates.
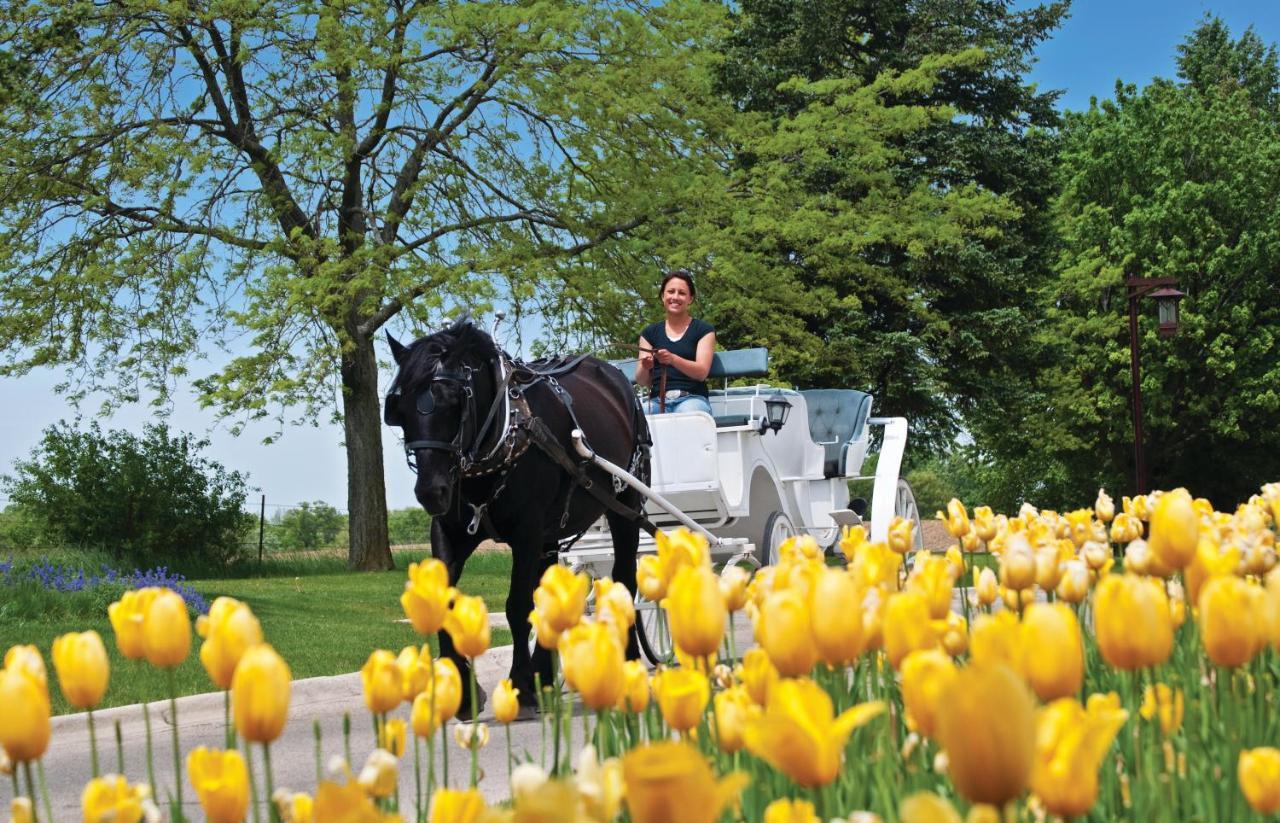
[0,421,246,566]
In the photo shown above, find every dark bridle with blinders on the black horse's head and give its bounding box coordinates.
[383,355,511,475]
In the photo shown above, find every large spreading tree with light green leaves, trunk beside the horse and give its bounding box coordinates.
[0,0,721,568]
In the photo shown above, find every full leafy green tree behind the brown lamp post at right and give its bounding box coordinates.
[1027,19,1280,508]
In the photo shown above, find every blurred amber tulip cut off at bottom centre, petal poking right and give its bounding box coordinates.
[622,741,748,823]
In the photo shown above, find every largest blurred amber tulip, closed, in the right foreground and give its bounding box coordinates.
[937,662,1036,808]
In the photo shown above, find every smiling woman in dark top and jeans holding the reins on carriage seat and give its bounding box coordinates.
[636,269,716,415]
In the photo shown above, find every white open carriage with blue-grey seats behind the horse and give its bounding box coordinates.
[561,348,923,662]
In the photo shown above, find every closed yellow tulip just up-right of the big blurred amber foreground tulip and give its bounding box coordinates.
[1021,603,1084,701]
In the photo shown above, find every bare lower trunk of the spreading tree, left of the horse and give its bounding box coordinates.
[342,332,396,571]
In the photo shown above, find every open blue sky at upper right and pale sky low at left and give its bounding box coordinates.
[0,0,1280,512]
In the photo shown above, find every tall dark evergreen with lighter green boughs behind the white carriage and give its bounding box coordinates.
[701,0,1068,453]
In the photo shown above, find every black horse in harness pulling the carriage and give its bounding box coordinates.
[384,319,649,718]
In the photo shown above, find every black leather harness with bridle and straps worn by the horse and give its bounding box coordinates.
[385,352,657,550]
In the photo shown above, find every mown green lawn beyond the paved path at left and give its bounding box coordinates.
[0,550,511,714]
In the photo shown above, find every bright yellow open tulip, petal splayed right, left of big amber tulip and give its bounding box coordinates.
[744,678,886,788]
